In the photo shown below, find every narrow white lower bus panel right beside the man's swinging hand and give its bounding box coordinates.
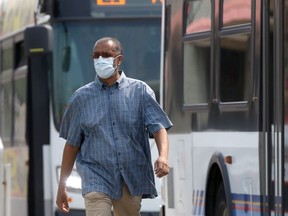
[163,134,194,216]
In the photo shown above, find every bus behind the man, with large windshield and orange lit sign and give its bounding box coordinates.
[0,0,162,216]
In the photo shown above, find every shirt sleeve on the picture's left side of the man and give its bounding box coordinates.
[59,97,83,146]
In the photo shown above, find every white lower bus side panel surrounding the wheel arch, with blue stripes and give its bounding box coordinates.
[192,132,260,215]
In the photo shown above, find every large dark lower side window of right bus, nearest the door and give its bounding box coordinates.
[219,34,252,102]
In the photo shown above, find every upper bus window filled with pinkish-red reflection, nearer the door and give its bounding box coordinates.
[222,0,252,27]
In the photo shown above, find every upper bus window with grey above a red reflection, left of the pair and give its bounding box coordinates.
[185,0,211,34]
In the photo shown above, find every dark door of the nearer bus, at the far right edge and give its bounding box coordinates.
[260,0,288,215]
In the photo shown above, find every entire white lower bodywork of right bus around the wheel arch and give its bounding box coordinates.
[165,132,260,215]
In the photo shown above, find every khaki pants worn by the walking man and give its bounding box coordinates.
[84,183,142,216]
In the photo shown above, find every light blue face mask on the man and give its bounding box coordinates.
[94,56,116,79]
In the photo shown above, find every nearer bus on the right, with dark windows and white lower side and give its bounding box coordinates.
[160,0,288,216]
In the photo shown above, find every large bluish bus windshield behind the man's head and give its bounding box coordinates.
[52,18,161,128]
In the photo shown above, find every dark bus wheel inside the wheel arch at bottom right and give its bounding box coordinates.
[214,182,228,216]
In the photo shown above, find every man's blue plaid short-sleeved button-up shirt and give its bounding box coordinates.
[60,72,172,199]
